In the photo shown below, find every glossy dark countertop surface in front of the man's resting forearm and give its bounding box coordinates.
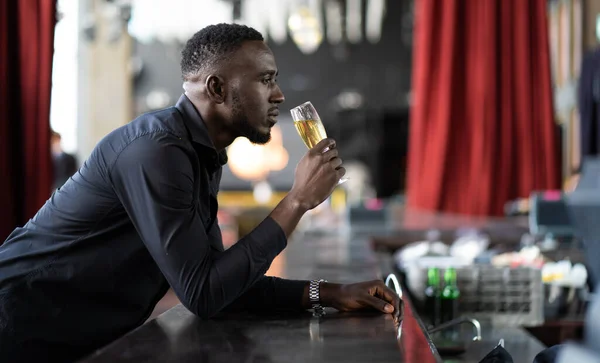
[79,305,401,363]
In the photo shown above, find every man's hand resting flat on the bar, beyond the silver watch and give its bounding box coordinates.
[321,280,400,316]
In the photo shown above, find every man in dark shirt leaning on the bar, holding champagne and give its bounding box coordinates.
[0,24,399,362]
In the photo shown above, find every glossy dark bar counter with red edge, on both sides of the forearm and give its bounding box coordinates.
[82,232,544,363]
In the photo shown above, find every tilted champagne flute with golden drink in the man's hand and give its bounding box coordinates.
[290,101,348,185]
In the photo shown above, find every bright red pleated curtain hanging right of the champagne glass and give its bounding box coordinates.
[407,0,560,215]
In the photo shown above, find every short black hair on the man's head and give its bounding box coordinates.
[181,23,264,81]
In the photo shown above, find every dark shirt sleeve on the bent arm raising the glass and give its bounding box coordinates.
[110,134,287,319]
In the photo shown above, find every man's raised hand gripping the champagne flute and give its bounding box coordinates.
[288,139,346,209]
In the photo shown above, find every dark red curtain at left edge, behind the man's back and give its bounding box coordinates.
[0,0,56,243]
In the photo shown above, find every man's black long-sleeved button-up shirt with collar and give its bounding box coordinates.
[0,95,306,362]
